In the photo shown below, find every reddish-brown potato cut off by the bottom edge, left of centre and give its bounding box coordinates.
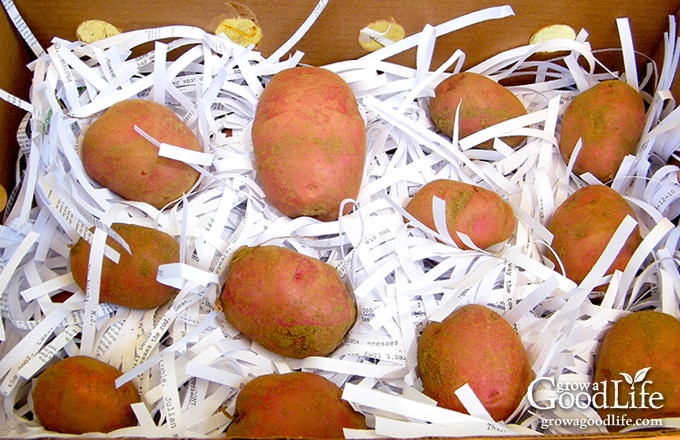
[227,371,366,439]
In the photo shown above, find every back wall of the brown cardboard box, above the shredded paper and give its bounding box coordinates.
[7,0,680,65]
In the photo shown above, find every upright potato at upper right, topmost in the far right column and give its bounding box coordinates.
[559,80,645,182]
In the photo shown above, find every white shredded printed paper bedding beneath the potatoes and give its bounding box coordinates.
[0,0,680,438]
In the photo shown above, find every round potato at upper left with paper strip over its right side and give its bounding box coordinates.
[82,99,202,209]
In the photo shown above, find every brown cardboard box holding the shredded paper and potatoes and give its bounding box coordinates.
[0,0,680,438]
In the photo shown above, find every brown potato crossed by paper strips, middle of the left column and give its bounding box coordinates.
[69,223,179,309]
